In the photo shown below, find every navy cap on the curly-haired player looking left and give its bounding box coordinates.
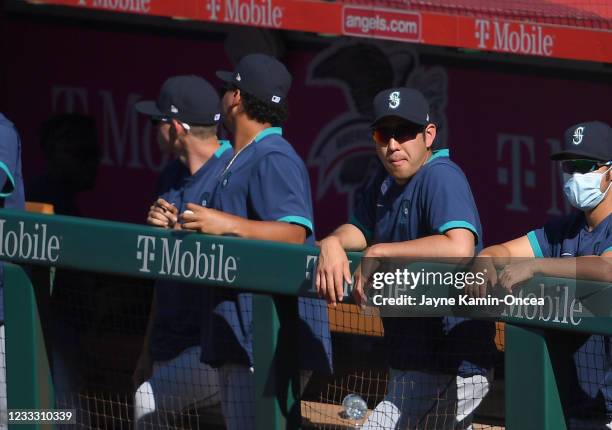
[217,54,292,105]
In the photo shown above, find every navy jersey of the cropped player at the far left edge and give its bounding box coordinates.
[0,113,25,321]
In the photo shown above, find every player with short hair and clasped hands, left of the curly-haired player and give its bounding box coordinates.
[134,76,232,428]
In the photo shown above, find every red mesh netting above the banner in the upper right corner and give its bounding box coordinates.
[343,0,612,30]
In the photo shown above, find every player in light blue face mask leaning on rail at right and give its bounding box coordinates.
[470,121,612,429]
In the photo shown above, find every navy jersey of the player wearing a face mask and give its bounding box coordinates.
[527,212,612,416]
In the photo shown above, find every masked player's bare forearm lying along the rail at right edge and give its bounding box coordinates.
[533,256,612,282]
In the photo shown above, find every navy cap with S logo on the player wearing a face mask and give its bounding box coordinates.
[550,121,612,161]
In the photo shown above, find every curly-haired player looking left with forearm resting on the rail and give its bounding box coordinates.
[182,54,331,430]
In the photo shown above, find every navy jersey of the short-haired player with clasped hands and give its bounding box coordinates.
[150,141,233,361]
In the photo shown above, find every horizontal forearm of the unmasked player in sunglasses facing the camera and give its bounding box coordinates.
[368,235,474,258]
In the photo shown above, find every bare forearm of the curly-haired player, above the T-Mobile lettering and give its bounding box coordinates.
[231,216,306,245]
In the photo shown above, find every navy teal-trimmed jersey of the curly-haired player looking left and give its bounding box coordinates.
[202,127,331,372]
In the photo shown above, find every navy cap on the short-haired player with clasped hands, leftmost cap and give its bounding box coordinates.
[134,75,221,125]
